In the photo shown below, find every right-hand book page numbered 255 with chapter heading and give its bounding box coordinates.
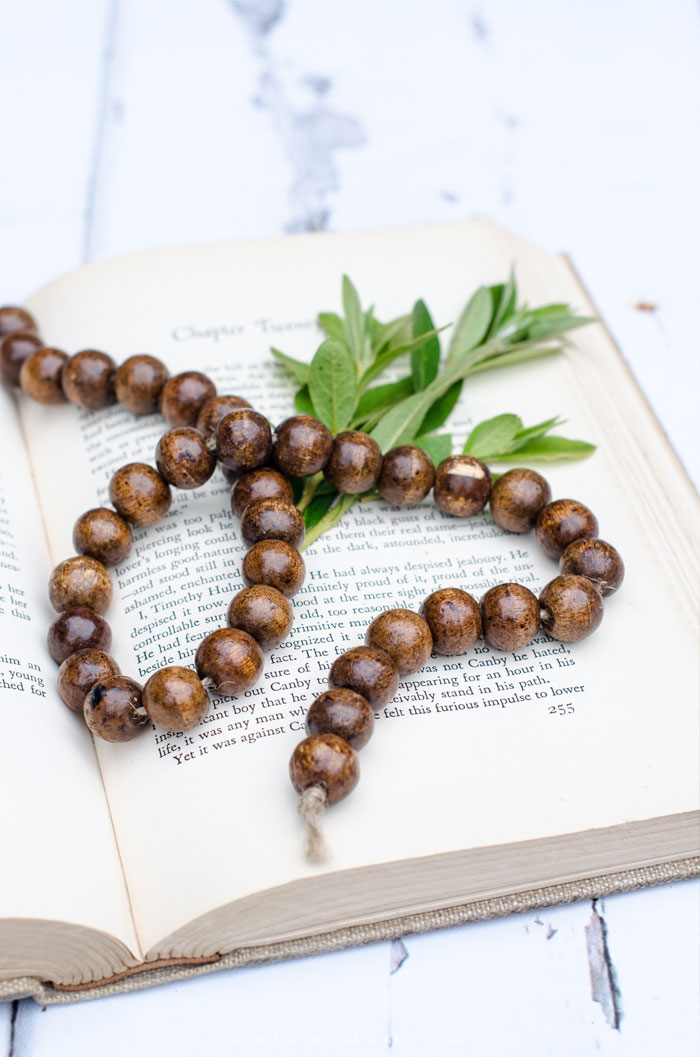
[22,222,698,953]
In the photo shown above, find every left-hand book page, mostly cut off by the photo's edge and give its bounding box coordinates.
[0,387,139,969]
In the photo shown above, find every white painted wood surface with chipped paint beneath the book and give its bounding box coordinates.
[0,0,700,1057]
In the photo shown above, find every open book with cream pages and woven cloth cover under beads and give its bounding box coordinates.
[0,221,699,1002]
